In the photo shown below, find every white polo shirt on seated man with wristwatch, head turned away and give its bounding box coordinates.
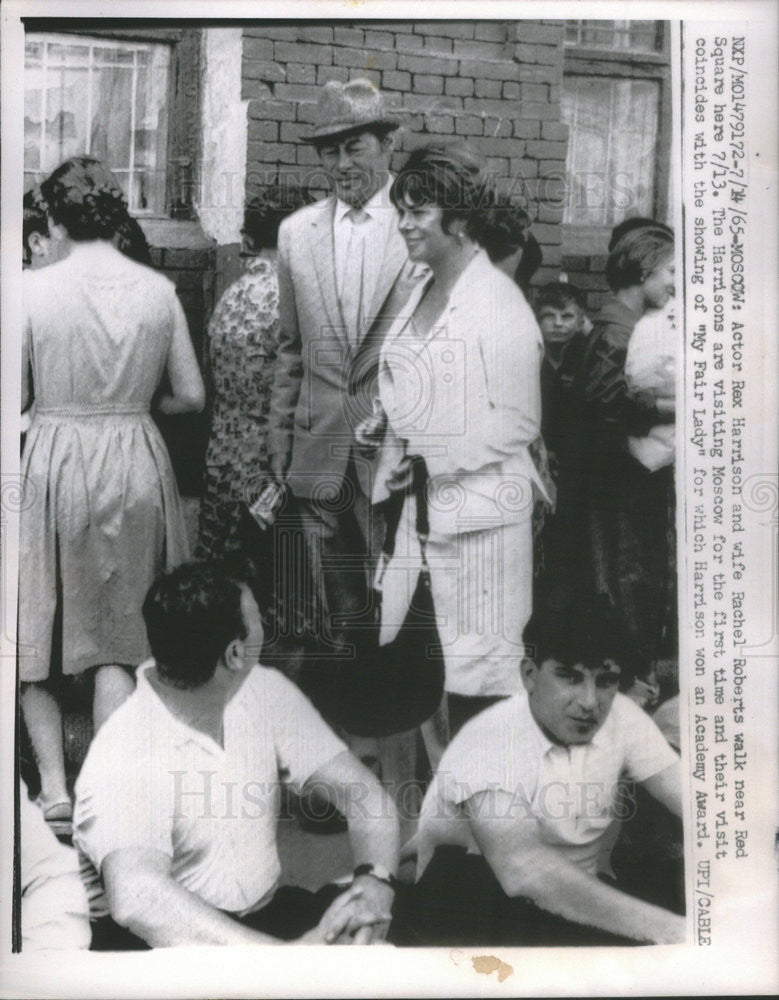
[73,660,346,914]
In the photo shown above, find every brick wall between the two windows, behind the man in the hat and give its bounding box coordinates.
[242,21,568,284]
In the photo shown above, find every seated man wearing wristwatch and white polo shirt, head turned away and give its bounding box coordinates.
[73,563,399,949]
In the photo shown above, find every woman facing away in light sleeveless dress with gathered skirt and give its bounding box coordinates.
[18,157,204,832]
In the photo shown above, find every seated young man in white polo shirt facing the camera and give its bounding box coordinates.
[391,598,684,945]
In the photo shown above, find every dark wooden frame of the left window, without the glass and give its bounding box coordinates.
[22,18,202,222]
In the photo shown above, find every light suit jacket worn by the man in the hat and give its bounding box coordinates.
[268,195,416,498]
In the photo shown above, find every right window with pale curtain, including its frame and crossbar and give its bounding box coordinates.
[562,21,671,253]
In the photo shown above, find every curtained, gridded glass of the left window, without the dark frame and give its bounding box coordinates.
[24,33,170,212]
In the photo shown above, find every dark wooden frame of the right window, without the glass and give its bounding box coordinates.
[563,21,673,254]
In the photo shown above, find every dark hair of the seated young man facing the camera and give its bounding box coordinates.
[522,593,645,689]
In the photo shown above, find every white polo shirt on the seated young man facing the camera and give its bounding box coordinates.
[418,690,678,875]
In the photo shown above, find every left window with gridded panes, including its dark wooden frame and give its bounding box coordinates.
[24,26,201,219]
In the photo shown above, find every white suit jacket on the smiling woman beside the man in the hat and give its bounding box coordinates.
[373,250,546,534]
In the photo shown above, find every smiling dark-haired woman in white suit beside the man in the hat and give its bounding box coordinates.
[374,146,543,734]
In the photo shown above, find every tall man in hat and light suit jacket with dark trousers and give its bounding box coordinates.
[268,79,417,728]
